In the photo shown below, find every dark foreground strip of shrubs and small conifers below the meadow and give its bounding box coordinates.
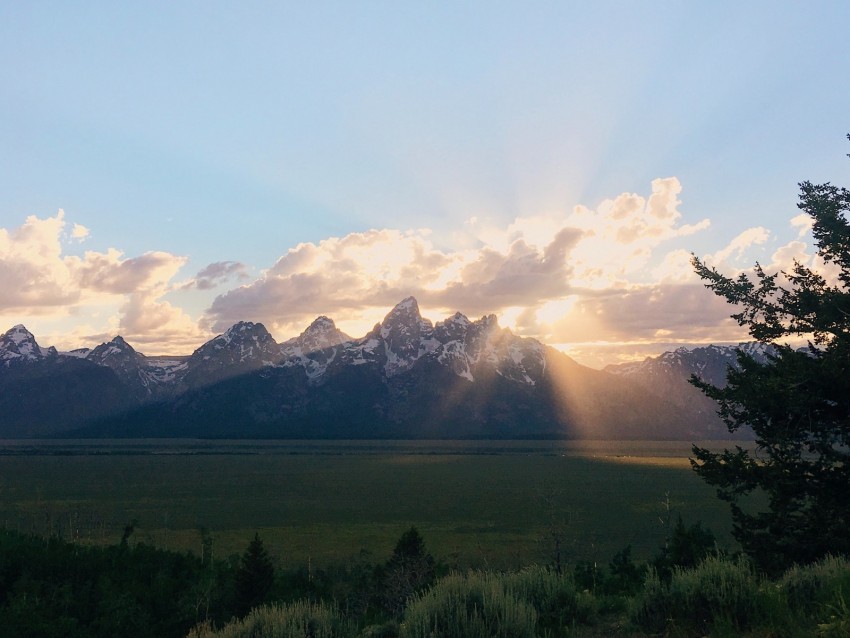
[0,520,850,638]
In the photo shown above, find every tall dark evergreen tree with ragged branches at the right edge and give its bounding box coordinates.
[691,142,850,573]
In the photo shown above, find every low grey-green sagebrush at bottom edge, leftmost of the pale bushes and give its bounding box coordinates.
[188,601,356,638]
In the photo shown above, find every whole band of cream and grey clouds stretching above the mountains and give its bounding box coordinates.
[6,177,817,363]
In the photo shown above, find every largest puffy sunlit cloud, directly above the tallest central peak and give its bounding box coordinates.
[206,178,708,332]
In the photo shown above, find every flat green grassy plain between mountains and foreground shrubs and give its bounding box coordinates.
[0,441,732,568]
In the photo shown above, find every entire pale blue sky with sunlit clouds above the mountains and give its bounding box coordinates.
[0,0,850,368]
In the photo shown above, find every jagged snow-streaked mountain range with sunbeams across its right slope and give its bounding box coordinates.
[0,297,766,440]
